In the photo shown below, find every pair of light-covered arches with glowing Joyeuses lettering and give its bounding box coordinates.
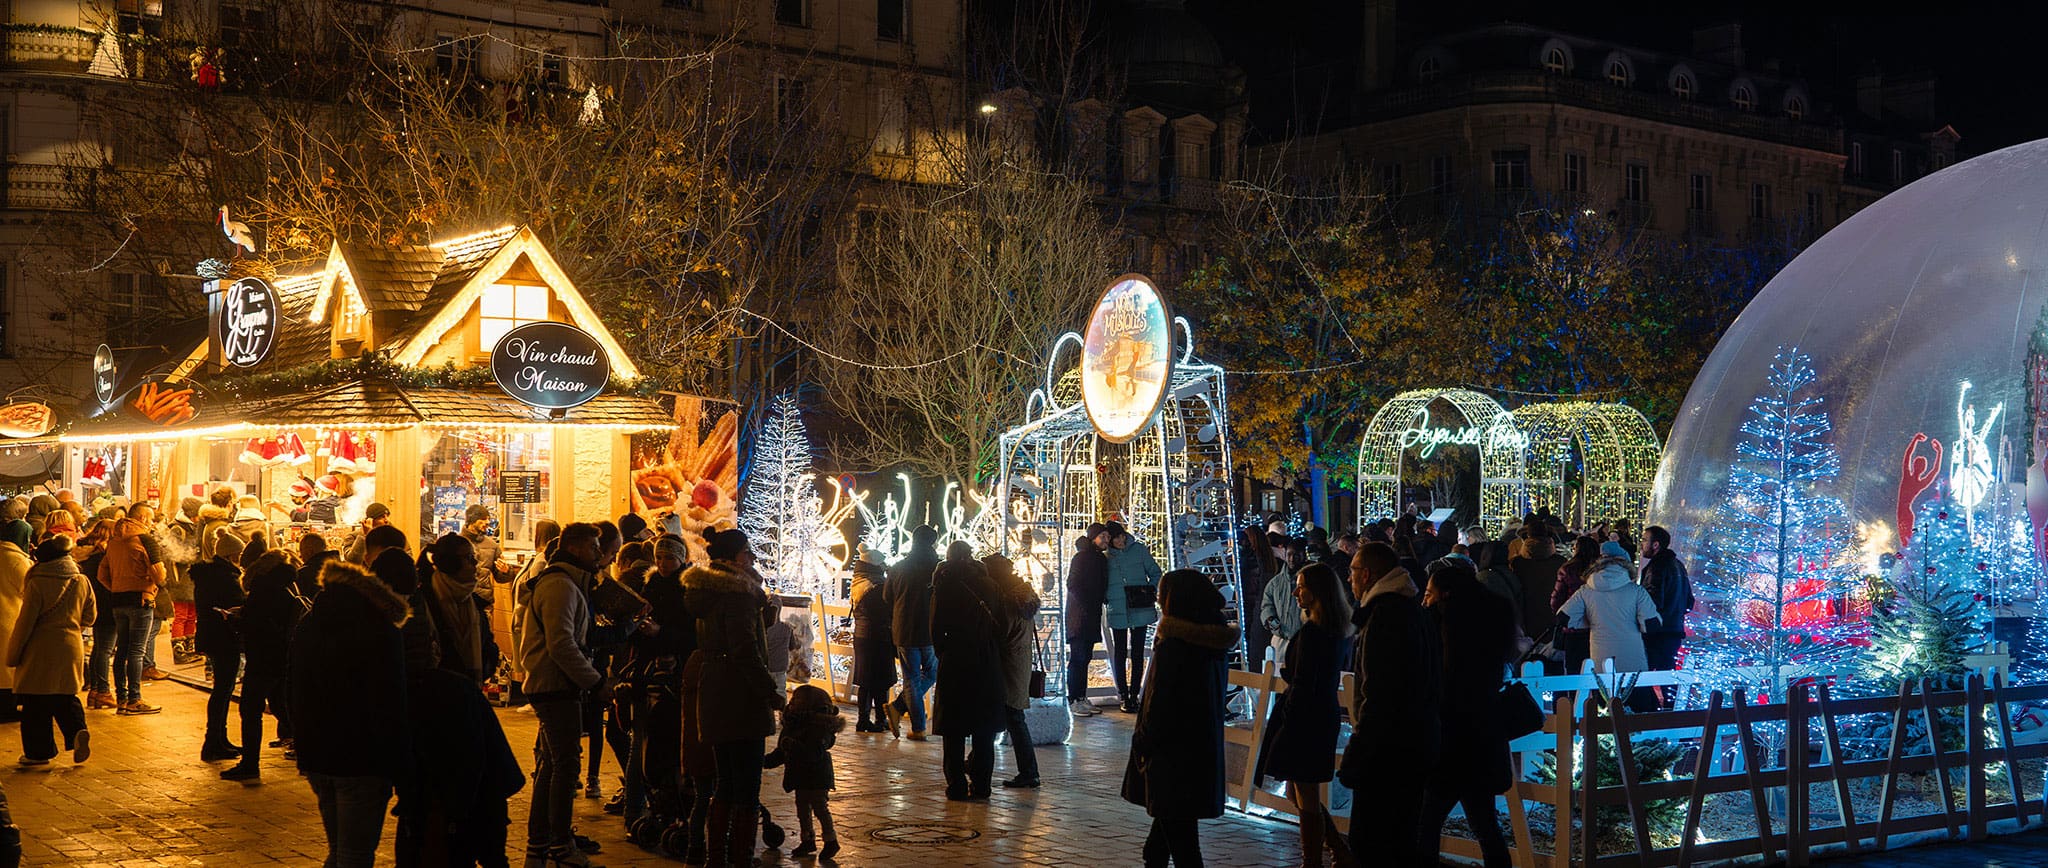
[1358,389,1663,532]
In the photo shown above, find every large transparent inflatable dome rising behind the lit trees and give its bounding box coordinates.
[1651,139,2048,553]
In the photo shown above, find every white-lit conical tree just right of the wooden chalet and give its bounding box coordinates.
[739,393,846,598]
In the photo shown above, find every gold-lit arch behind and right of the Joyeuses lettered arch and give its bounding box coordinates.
[1513,401,1663,534]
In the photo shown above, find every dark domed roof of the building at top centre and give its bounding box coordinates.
[1114,0,1229,117]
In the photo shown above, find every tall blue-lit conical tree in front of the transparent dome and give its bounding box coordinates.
[1686,348,1866,696]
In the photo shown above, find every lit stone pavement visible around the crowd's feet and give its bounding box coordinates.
[0,649,1296,868]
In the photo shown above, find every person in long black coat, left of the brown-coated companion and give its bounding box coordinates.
[932,540,1010,802]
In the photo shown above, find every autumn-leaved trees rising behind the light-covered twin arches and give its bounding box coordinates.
[1174,178,1794,515]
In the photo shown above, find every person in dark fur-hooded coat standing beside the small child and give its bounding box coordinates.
[682,530,784,866]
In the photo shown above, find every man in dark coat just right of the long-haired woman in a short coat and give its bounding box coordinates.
[1337,543,1442,866]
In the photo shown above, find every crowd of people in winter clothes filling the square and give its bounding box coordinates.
[0,487,1692,868]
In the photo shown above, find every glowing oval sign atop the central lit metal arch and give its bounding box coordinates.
[1081,274,1174,442]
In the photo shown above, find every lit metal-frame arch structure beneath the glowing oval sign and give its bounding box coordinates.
[991,278,1243,696]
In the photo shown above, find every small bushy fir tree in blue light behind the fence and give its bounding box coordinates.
[1864,497,2005,690]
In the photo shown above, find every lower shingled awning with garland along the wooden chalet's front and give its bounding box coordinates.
[61,381,676,442]
